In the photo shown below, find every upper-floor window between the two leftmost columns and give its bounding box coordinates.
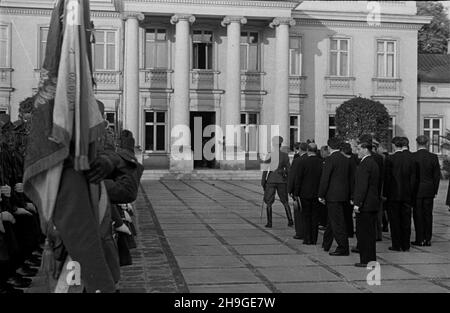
[145,28,169,68]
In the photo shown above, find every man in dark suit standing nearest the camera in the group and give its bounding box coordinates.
[353,137,380,267]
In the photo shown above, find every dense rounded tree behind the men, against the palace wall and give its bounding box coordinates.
[336,97,389,143]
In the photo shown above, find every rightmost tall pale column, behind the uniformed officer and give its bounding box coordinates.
[270,17,295,151]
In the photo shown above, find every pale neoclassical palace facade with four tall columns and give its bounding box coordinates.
[0,0,430,169]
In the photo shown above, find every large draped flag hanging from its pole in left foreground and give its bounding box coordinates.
[24,0,104,231]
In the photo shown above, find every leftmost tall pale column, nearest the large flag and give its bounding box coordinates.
[122,12,144,145]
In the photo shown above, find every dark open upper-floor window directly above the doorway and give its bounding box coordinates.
[192,30,213,70]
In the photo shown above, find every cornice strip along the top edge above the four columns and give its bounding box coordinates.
[125,0,300,9]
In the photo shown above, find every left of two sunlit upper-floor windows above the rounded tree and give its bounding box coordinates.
[330,39,350,76]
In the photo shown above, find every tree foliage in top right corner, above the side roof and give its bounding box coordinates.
[417,1,450,54]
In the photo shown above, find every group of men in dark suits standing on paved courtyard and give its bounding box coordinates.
[263,135,440,267]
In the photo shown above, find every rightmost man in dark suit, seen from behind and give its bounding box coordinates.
[411,136,441,246]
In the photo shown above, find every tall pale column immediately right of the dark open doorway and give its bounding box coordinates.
[221,16,247,169]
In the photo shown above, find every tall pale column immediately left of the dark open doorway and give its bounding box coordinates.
[170,14,195,171]
